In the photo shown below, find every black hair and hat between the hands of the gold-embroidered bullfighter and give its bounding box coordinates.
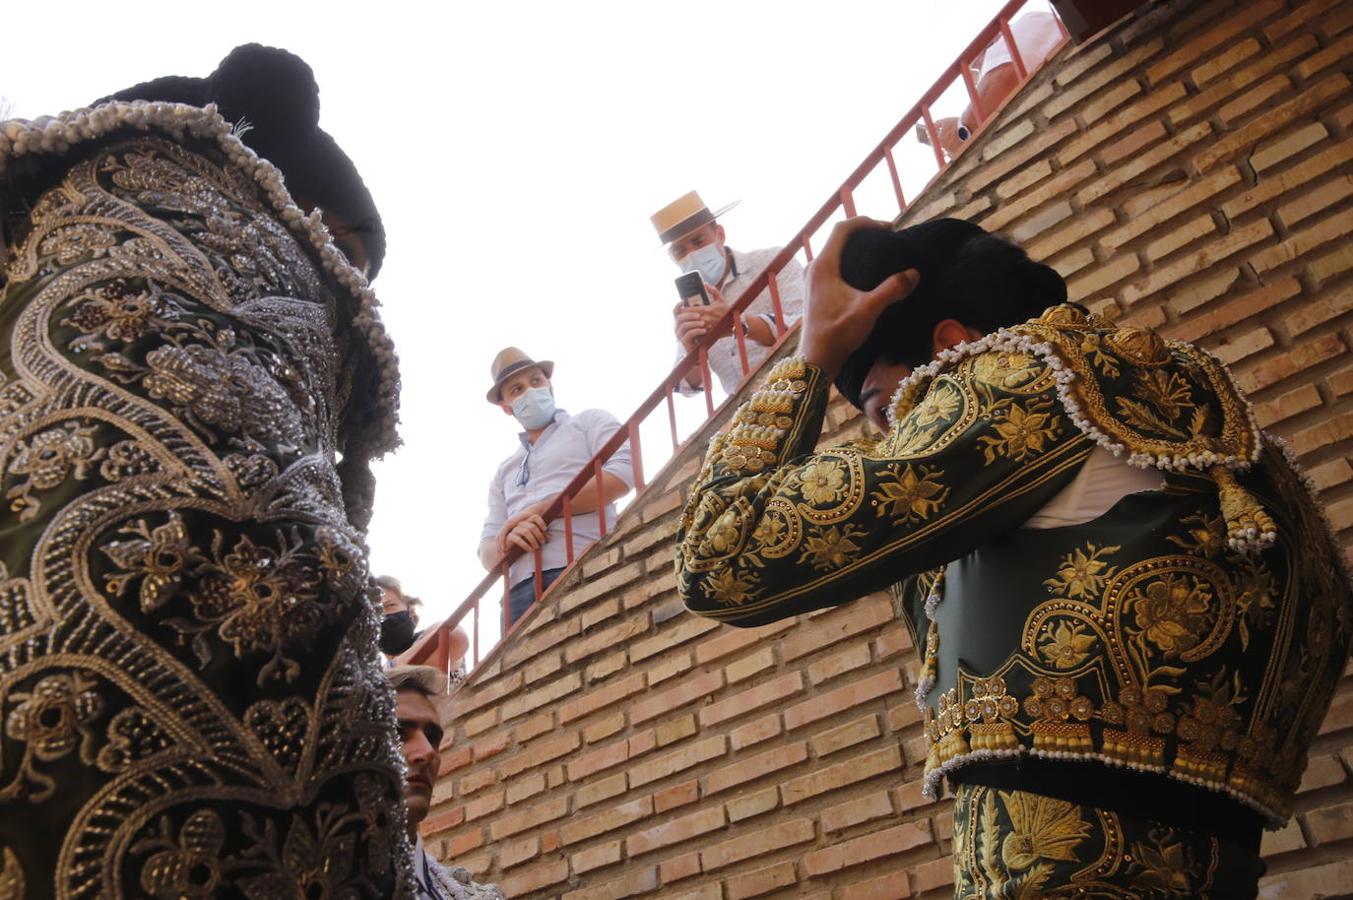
[836,219,1066,407]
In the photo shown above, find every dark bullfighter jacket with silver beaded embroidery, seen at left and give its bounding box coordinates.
[0,103,413,900]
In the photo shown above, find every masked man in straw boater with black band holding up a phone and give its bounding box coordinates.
[651,191,804,394]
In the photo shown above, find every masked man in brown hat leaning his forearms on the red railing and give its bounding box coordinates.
[479,346,635,624]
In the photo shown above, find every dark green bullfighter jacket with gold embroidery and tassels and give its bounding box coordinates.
[677,306,1353,824]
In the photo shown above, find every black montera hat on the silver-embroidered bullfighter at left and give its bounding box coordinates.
[99,43,386,279]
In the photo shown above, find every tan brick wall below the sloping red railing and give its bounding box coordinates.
[425,0,1353,900]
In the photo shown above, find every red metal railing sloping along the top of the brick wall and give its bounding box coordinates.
[403,0,1068,670]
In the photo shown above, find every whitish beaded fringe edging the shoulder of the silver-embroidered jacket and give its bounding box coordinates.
[0,100,399,455]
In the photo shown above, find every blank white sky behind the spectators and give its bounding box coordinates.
[0,0,1017,646]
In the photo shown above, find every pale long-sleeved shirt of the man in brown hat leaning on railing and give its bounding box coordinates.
[479,409,635,585]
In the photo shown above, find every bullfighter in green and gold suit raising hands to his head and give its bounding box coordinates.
[677,219,1353,897]
